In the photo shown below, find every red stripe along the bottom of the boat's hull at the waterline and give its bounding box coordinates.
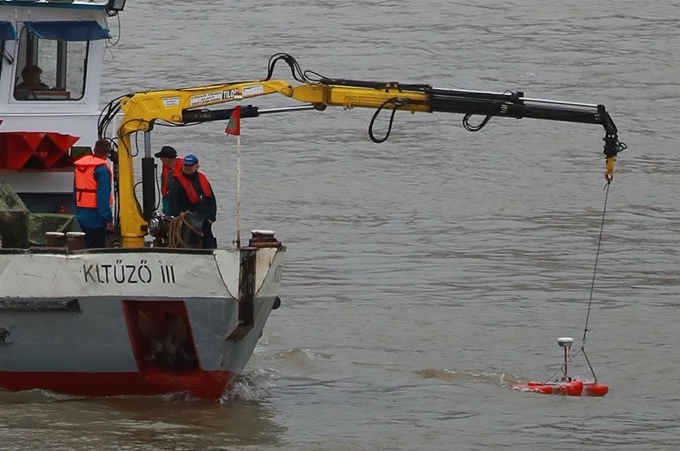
[0,371,234,400]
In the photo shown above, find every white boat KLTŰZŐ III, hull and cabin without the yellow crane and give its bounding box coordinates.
[0,0,286,399]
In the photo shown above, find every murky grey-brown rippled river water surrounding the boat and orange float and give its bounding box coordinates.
[0,0,680,450]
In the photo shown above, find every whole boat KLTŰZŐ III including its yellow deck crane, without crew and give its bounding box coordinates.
[0,0,625,400]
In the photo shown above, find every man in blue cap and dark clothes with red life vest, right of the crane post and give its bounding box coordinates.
[168,154,217,249]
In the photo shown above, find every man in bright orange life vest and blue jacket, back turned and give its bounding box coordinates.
[74,139,113,249]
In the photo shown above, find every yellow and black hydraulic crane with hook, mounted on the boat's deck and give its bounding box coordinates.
[99,54,626,247]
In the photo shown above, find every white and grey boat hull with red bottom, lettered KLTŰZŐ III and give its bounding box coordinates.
[0,247,285,398]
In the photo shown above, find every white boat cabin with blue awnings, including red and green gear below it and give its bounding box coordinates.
[0,0,117,248]
